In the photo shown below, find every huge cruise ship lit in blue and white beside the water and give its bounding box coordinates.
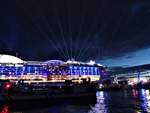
[0,55,106,81]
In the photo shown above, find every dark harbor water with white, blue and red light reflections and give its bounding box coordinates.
[0,89,150,113]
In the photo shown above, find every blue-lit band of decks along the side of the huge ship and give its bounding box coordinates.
[0,62,104,79]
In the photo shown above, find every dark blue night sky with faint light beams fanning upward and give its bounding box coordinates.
[0,0,150,66]
